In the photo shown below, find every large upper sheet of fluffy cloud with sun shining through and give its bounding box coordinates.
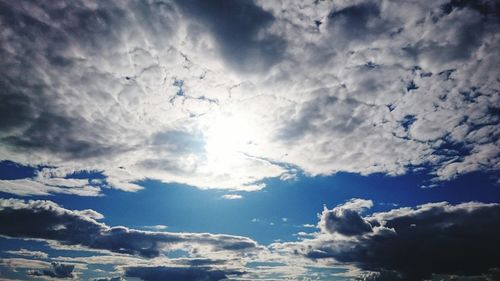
[0,0,500,196]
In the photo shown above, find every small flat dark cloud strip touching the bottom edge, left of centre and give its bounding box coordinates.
[126,267,242,281]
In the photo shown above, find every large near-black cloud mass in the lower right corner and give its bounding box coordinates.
[307,202,500,280]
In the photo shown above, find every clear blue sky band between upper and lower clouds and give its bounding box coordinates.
[0,162,500,244]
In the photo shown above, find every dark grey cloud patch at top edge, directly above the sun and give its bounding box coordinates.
[178,0,286,72]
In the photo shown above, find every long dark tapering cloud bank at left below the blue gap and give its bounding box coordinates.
[0,199,258,258]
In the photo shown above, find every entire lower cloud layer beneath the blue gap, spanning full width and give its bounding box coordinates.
[0,196,500,281]
